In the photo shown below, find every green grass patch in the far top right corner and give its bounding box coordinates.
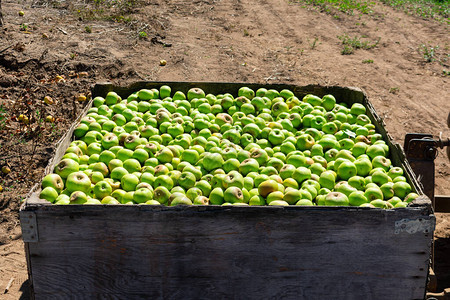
[381,0,450,24]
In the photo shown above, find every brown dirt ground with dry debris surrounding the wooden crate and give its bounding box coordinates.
[0,0,450,299]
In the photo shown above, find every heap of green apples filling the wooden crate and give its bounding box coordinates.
[40,85,418,208]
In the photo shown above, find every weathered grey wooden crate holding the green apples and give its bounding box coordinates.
[20,82,435,300]
